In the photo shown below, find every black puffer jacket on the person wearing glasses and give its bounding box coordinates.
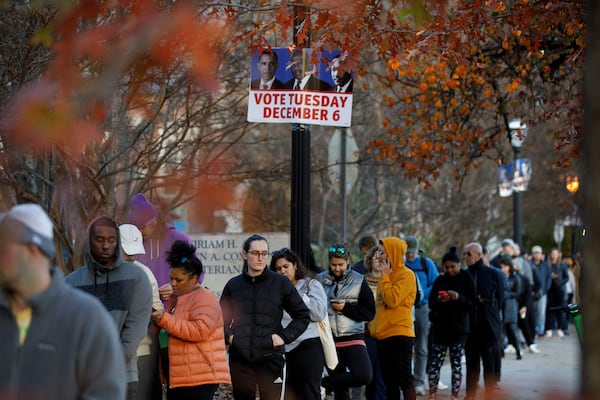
[220,268,310,361]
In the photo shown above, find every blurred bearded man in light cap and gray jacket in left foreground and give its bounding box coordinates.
[0,204,126,400]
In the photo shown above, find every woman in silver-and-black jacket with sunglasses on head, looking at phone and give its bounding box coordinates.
[317,244,375,400]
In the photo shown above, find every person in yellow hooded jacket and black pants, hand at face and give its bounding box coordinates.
[369,237,417,400]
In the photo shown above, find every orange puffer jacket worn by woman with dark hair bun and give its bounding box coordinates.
[158,286,231,388]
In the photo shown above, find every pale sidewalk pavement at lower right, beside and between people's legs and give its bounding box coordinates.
[432,326,581,400]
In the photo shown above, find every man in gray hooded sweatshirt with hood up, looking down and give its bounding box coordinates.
[65,216,152,400]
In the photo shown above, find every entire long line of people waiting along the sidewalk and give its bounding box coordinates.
[0,198,581,400]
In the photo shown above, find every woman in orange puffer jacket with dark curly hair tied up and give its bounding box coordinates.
[152,241,231,400]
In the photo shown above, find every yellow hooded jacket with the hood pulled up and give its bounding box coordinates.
[369,237,417,339]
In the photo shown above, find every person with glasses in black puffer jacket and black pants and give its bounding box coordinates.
[220,235,310,400]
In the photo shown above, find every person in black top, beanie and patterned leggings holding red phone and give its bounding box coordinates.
[428,247,476,400]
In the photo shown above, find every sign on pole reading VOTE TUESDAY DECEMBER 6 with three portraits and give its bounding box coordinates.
[247,48,354,127]
